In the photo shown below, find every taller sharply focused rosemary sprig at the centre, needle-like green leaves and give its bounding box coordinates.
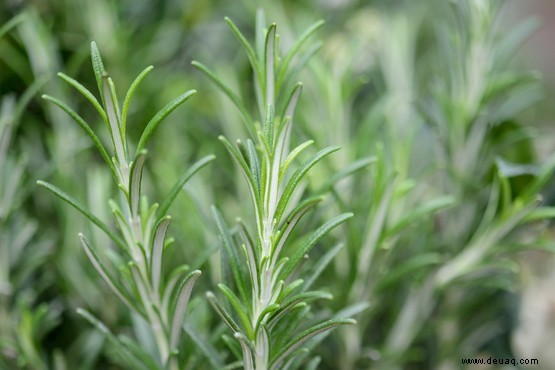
[193,12,354,370]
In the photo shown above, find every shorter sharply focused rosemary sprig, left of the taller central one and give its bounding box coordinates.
[34,42,214,369]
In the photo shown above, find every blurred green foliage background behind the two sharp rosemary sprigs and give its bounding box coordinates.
[0,0,555,370]
